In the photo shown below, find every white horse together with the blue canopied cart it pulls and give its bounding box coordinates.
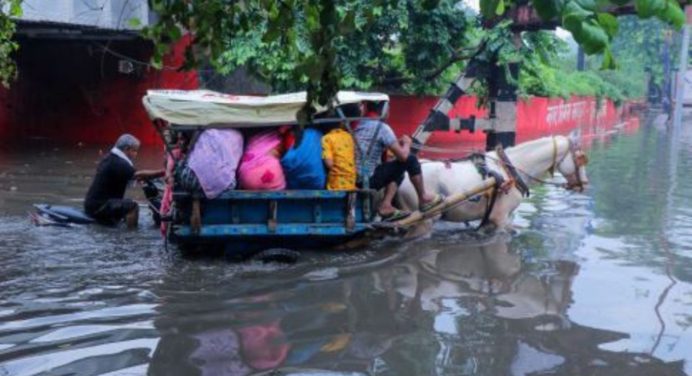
[143,90,588,258]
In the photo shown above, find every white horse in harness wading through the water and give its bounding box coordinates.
[398,135,588,227]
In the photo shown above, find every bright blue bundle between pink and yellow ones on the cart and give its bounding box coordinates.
[281,128,327,189]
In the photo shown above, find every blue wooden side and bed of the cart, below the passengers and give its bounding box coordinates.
[169,190,372,254]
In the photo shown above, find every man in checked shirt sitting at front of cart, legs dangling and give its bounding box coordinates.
[355,101,443,221]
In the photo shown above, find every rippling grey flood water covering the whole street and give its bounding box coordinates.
[0,115,692,375]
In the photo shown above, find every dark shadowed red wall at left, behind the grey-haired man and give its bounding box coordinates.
[0,35,198,144]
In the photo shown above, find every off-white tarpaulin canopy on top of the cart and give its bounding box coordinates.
[142,90,389,127]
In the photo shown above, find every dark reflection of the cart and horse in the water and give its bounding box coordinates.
[142,228,682,375]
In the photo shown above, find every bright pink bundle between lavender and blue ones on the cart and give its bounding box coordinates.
[238,131,286,191]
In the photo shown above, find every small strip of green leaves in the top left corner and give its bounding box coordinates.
[0,0,22,87]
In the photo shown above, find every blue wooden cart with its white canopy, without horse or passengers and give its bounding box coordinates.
[143,90,389,256]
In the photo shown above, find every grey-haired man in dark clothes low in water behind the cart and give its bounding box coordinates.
[84,134,164,228]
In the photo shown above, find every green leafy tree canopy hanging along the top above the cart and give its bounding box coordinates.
[142,0,684,108]
